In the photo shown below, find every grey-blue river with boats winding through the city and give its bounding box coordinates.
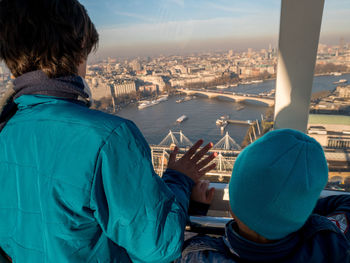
[117,74,350,144]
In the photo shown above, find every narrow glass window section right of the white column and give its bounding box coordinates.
[308,0,350,194]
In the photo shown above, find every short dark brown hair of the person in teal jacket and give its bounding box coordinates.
[0,0,98,78]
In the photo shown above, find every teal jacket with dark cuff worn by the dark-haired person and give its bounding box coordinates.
[0,95,193,263]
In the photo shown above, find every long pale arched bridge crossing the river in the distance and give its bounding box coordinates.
[176,89,275,107]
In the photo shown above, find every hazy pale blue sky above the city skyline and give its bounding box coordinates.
[81,0,350,59]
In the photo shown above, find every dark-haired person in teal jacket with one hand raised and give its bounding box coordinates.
[0,0,216,263]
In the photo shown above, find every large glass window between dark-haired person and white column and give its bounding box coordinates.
[82,0,280,185]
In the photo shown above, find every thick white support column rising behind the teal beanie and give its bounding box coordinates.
[275,0,324,132]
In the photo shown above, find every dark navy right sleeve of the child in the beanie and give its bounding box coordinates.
[313,195,350,240]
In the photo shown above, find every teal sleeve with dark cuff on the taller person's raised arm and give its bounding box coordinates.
[90,122,193,262]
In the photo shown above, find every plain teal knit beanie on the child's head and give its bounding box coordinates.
[229,129,328,240]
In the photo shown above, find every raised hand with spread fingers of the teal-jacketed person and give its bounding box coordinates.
[168,140,217,183]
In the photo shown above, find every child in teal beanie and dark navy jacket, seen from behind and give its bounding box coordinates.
[178,129,350,263]
